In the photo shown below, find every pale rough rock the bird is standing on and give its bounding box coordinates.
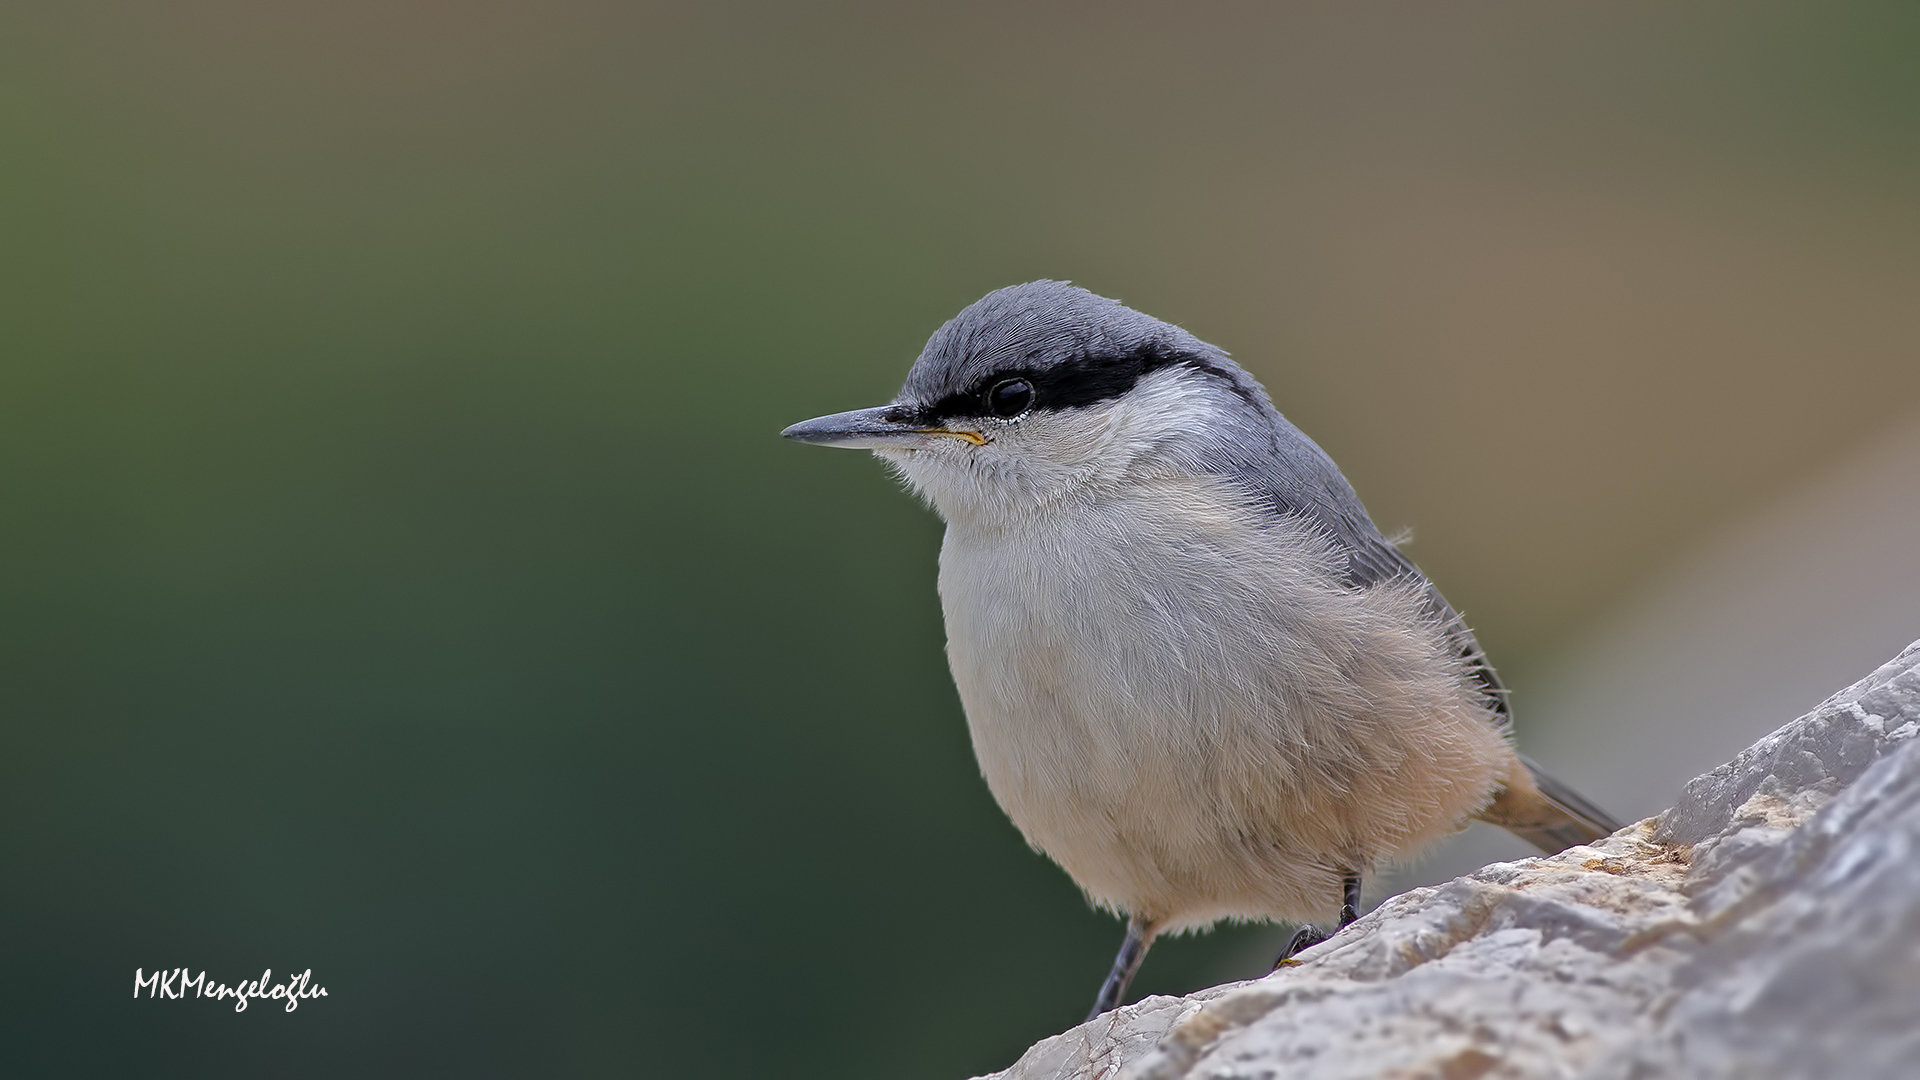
[975,642,1920,1080]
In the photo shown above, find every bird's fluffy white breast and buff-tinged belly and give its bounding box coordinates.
[941,477,1509,928]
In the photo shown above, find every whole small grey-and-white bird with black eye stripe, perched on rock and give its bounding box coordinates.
[781,281,1619,1019]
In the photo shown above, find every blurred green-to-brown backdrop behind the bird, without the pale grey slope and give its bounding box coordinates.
[0,0,1920,1078]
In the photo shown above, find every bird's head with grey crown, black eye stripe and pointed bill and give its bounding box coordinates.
[781,281,1273,521]
